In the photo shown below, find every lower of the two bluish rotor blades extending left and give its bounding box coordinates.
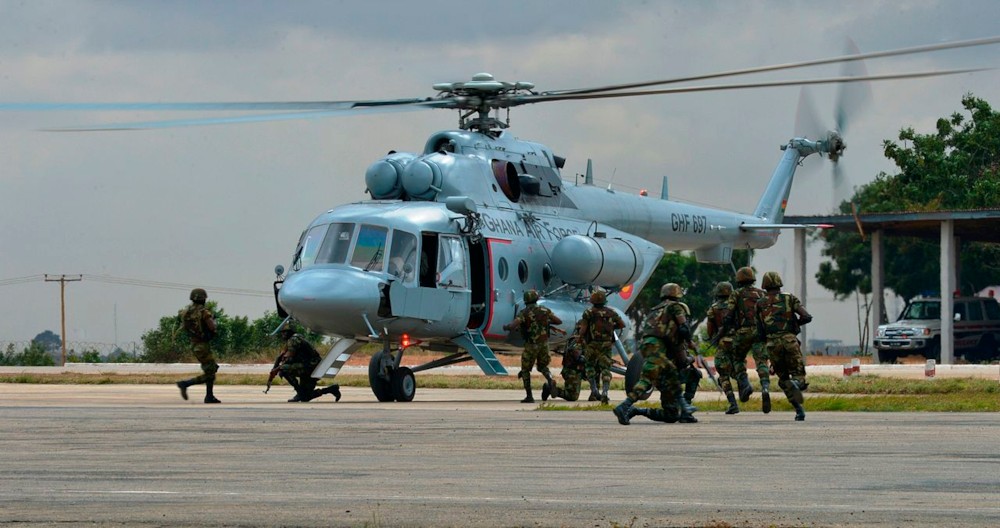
[36,101,450,132]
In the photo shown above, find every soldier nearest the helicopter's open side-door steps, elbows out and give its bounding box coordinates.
[503,290,562,403]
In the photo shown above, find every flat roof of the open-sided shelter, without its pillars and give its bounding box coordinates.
[784,208,1000,243]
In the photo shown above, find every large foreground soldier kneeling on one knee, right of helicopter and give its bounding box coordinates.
[614,282,698,425]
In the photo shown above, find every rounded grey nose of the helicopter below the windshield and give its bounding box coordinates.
[278,268,380,335]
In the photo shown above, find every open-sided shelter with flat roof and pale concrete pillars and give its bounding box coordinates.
[784,208,1000,364]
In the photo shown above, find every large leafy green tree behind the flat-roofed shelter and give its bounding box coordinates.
[816,95,1000,299]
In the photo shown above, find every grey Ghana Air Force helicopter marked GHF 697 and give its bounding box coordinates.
[0,37,1000,402]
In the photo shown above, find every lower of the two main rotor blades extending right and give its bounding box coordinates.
[509,68,996,106]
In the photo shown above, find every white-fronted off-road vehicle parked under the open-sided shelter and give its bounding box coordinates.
[875,297,1000,363]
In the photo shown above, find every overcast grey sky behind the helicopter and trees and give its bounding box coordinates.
[0,0,1000,350]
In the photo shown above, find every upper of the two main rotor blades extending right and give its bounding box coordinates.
[542,36,1000,95]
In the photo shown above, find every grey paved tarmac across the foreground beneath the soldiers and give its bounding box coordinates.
[0,384,1000,527]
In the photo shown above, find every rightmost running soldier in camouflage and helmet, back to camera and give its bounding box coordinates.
[757,271,812,422]
